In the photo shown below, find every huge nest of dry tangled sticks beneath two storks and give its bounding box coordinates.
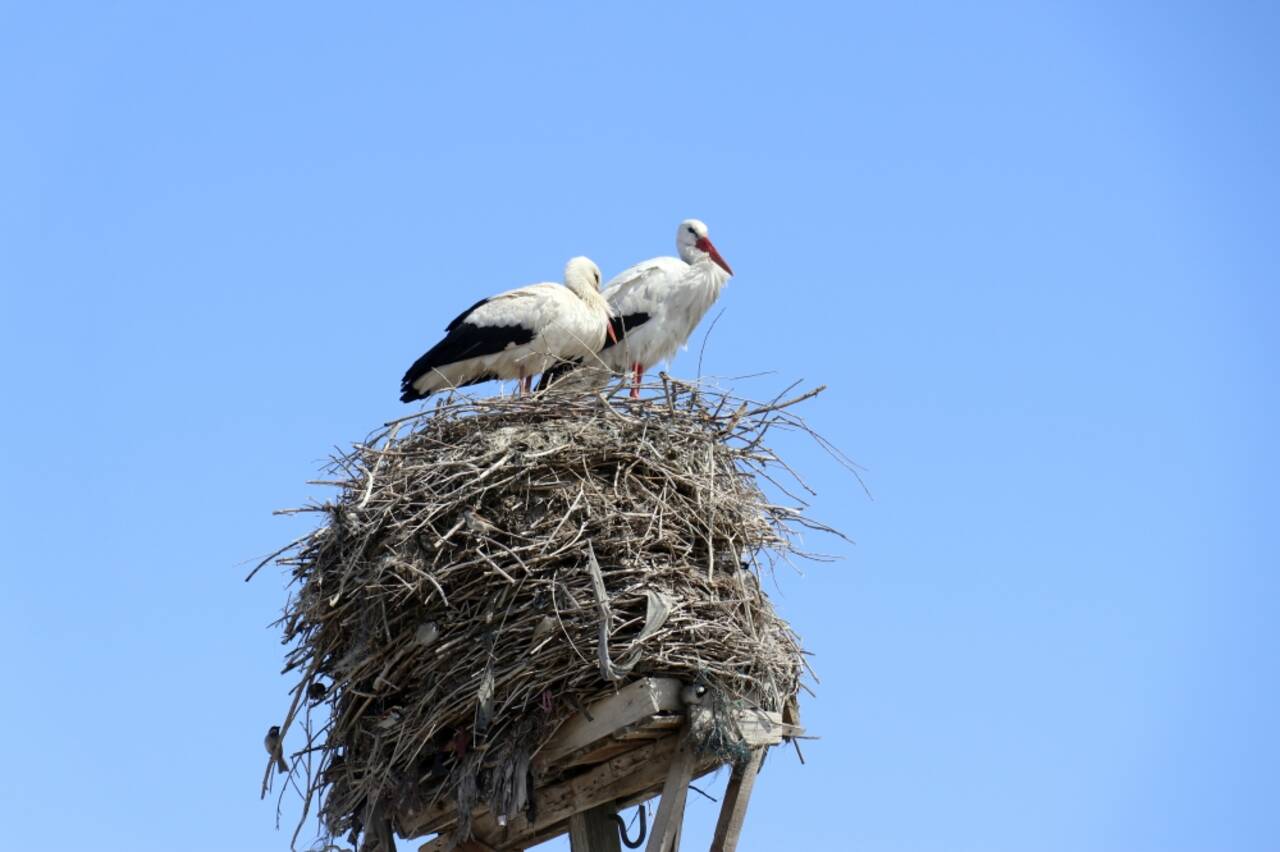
[254,379,844,843]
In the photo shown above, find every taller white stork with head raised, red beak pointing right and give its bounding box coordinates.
[600,219,733,398]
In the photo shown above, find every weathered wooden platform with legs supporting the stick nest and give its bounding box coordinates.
[401,678,804,852]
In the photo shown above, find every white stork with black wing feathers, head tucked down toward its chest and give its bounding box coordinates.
[401,257,614,402]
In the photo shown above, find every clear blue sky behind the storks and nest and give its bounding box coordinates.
[0,3,1280,852]
